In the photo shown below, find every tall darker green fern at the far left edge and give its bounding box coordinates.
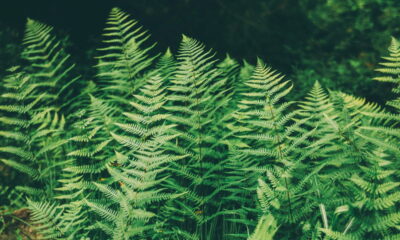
[0,19,79,204]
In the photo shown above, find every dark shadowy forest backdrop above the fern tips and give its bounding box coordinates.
[0,0,400,102]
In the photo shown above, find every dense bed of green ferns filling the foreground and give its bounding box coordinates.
[0,8,400,240]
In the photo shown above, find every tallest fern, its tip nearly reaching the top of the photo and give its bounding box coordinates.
[96,8,154,106]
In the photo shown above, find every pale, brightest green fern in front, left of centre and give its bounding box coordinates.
[88,71,185,239]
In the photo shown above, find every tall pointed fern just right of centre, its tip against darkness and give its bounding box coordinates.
[225,60,312,240]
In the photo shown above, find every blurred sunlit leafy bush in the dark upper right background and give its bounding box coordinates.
[291,0,399,104]
